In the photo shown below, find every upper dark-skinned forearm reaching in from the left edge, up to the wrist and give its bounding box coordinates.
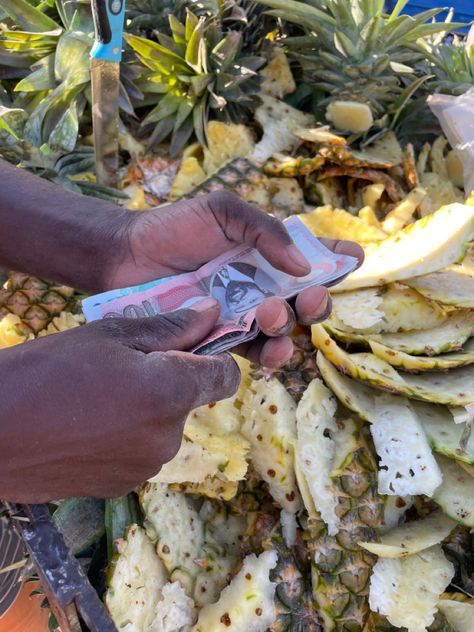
[0,160,131,291]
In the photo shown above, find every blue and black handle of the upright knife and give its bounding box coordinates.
[91,0,125,62]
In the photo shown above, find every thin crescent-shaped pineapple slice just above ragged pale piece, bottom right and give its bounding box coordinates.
[359,511,457,559]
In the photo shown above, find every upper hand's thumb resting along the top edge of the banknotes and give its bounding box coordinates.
[206,191,311,276]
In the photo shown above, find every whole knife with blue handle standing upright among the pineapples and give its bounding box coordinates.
[90,0,125,186]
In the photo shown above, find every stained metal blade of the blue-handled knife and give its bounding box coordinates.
[91,59,120,186]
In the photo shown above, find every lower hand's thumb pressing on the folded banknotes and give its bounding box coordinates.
[93,298,220,353]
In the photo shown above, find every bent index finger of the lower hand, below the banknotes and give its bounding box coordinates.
[147,351,240,410]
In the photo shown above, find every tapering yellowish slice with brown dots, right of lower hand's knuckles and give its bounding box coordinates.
[241,378,302,514]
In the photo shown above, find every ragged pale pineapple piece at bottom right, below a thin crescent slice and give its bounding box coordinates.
[369,544,454,632]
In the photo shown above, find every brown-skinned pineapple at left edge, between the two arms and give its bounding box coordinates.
[0,272,77,335]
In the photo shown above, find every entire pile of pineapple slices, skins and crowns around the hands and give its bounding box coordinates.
[0,0,474,632]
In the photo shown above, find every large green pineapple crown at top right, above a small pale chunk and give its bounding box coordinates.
[254,0,450,126]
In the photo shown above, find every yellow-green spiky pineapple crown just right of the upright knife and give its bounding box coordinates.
[126,10,265,156]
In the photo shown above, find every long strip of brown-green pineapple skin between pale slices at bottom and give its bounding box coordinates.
[305,420,383,632]
